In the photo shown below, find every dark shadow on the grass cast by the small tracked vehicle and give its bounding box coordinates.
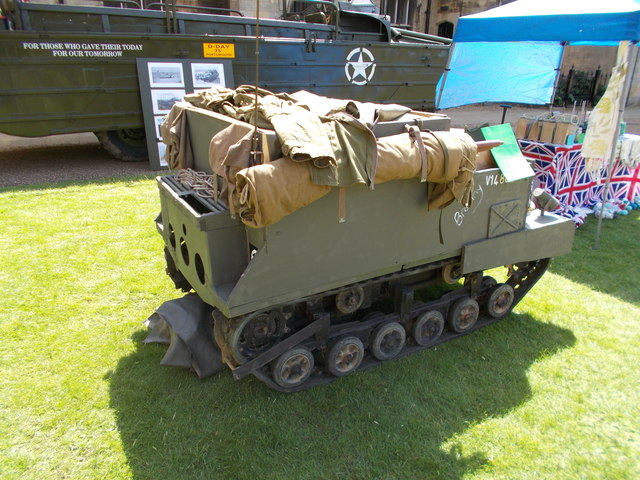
[108,314,575,480]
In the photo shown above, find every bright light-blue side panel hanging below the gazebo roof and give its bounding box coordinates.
[439,42,562,109]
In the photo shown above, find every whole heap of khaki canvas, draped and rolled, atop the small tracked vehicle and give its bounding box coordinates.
[163,87,477,228]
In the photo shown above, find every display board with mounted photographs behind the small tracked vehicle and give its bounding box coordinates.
[136,58,235,170]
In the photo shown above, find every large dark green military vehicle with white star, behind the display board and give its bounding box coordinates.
[0,0,449,161]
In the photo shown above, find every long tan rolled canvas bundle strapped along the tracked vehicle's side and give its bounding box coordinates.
[233,131,476,228]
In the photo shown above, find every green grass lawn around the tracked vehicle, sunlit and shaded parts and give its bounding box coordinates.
[0,179,640,480]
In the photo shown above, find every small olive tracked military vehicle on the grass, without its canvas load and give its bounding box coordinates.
[150,95,574,392]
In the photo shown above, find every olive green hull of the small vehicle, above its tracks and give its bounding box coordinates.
[158,169,574,318]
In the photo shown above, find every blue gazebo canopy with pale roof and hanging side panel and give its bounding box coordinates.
[438,0,640,109]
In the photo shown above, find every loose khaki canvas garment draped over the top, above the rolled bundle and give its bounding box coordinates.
[185,85,410,186]
